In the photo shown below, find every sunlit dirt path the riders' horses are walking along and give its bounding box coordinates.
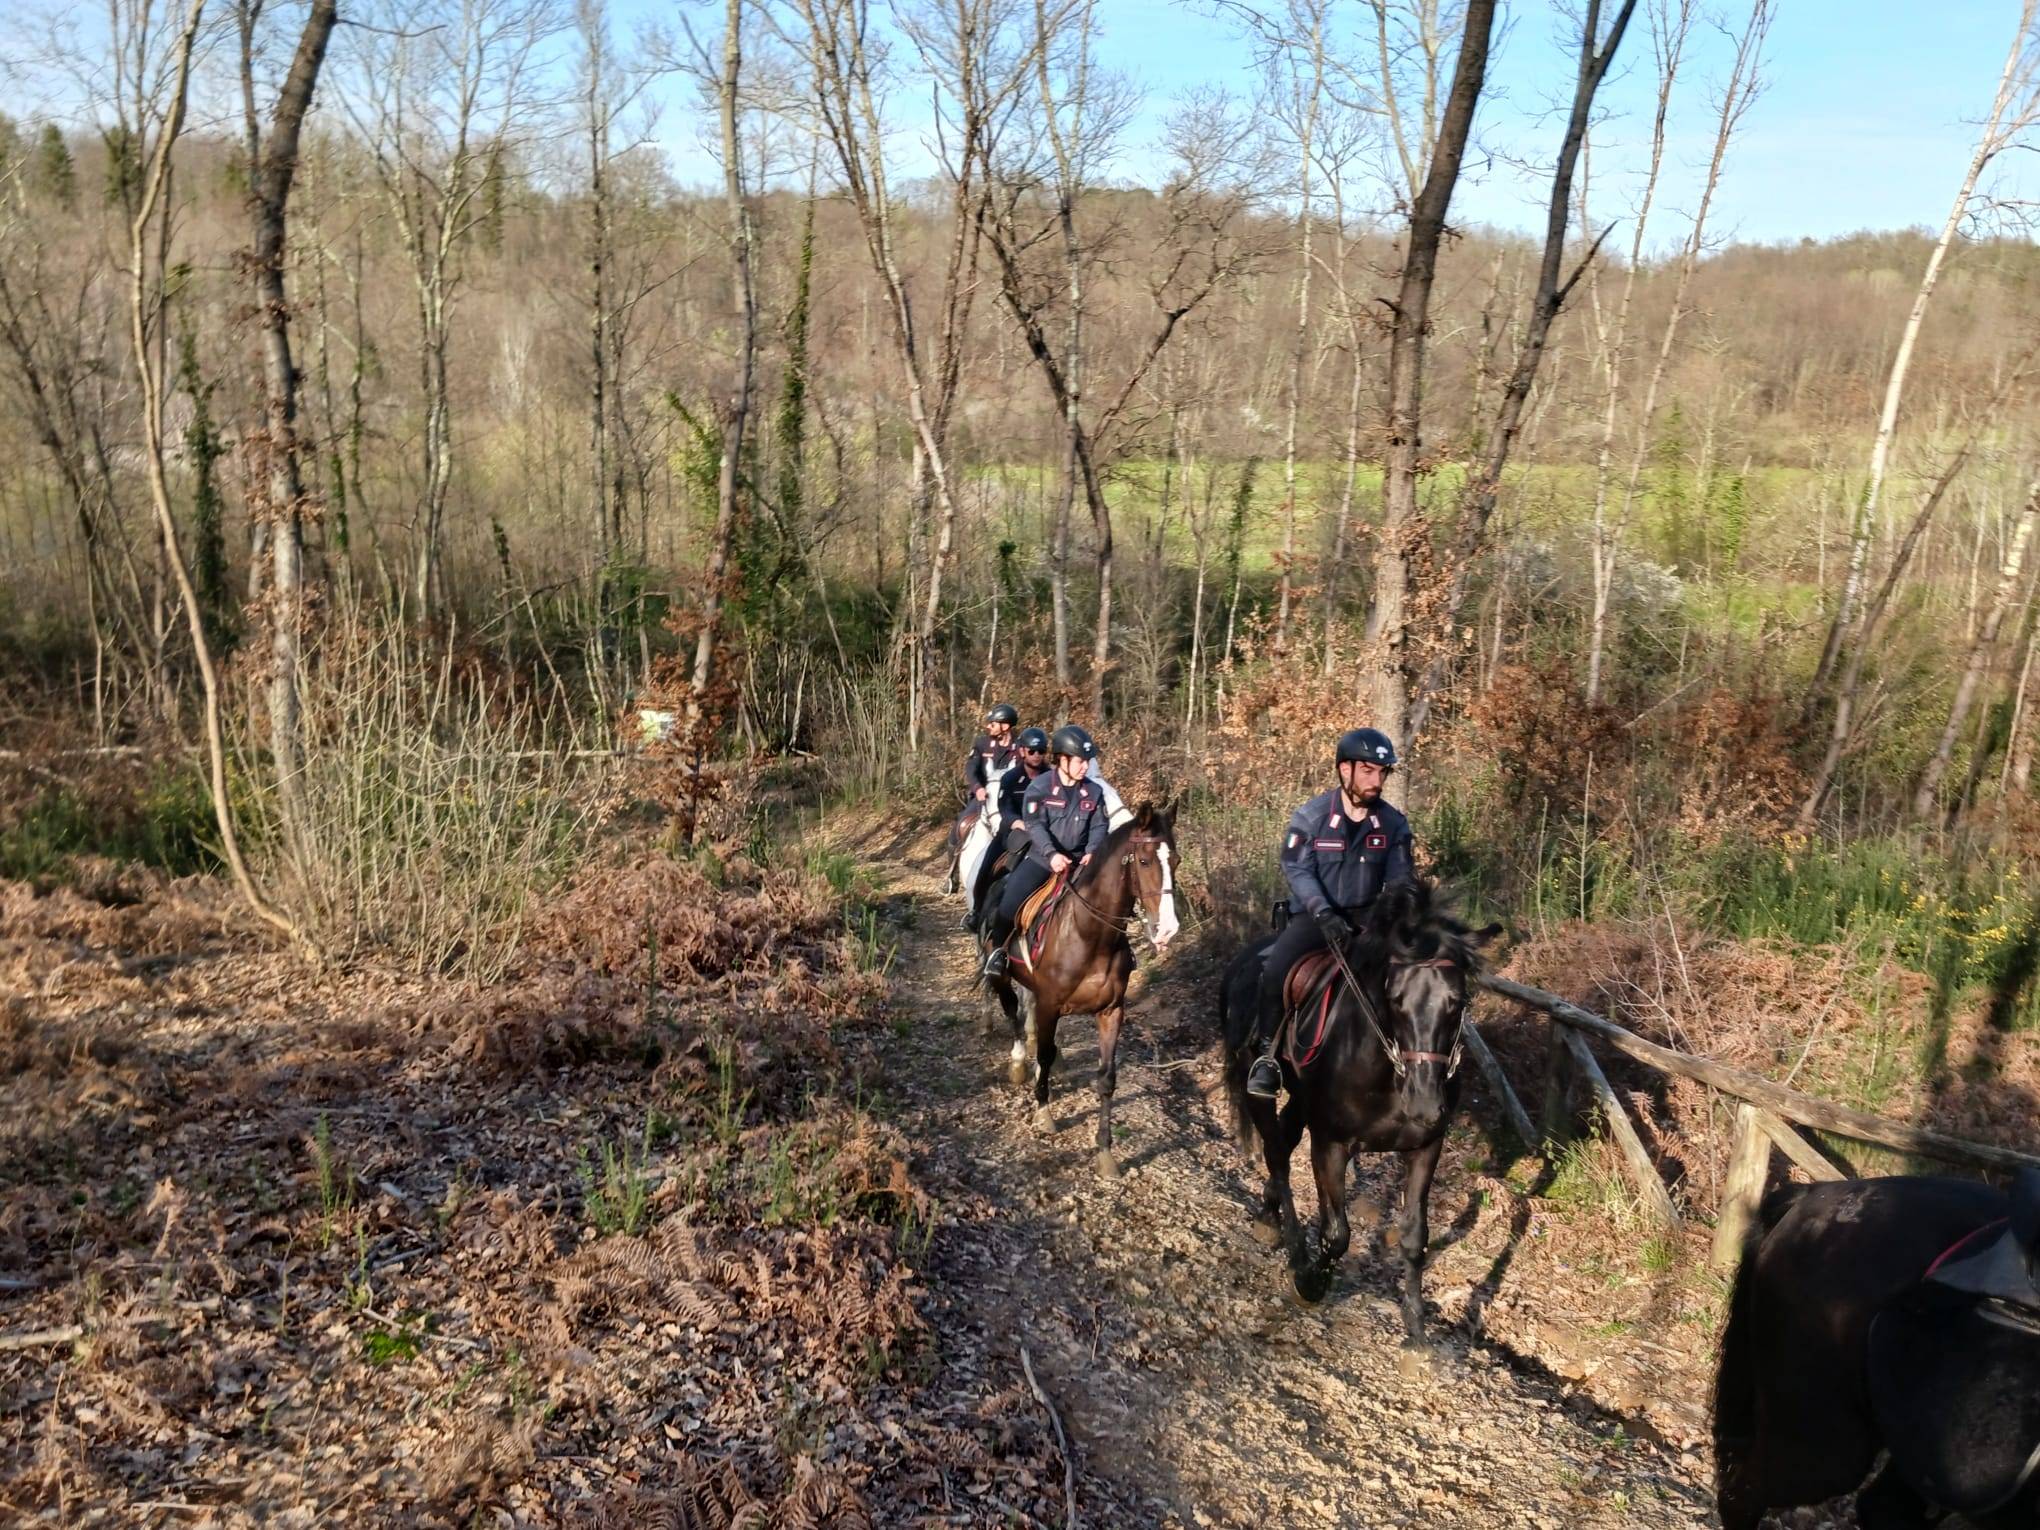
[853,838,1714,1528]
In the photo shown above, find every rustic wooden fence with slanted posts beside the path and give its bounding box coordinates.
[1467,977,2040,1267]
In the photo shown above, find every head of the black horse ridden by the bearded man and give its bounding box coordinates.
[1367,881,1501,1104]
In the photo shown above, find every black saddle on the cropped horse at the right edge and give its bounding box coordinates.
[1869,1169,2040,1516]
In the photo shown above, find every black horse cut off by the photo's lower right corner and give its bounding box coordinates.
[1714,1169,2040,1530]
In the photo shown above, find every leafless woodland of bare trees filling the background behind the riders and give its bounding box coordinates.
[0,0,2036,954]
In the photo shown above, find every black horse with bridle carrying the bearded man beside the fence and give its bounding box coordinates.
[1218,883,1501,1348]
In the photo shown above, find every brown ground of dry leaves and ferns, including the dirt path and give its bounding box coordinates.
[0,814,1893,1530]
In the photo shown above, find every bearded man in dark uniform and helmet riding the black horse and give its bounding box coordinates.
[1246,728,1416,1100]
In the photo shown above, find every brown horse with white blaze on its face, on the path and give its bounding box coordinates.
[987,802,1179,1175]
